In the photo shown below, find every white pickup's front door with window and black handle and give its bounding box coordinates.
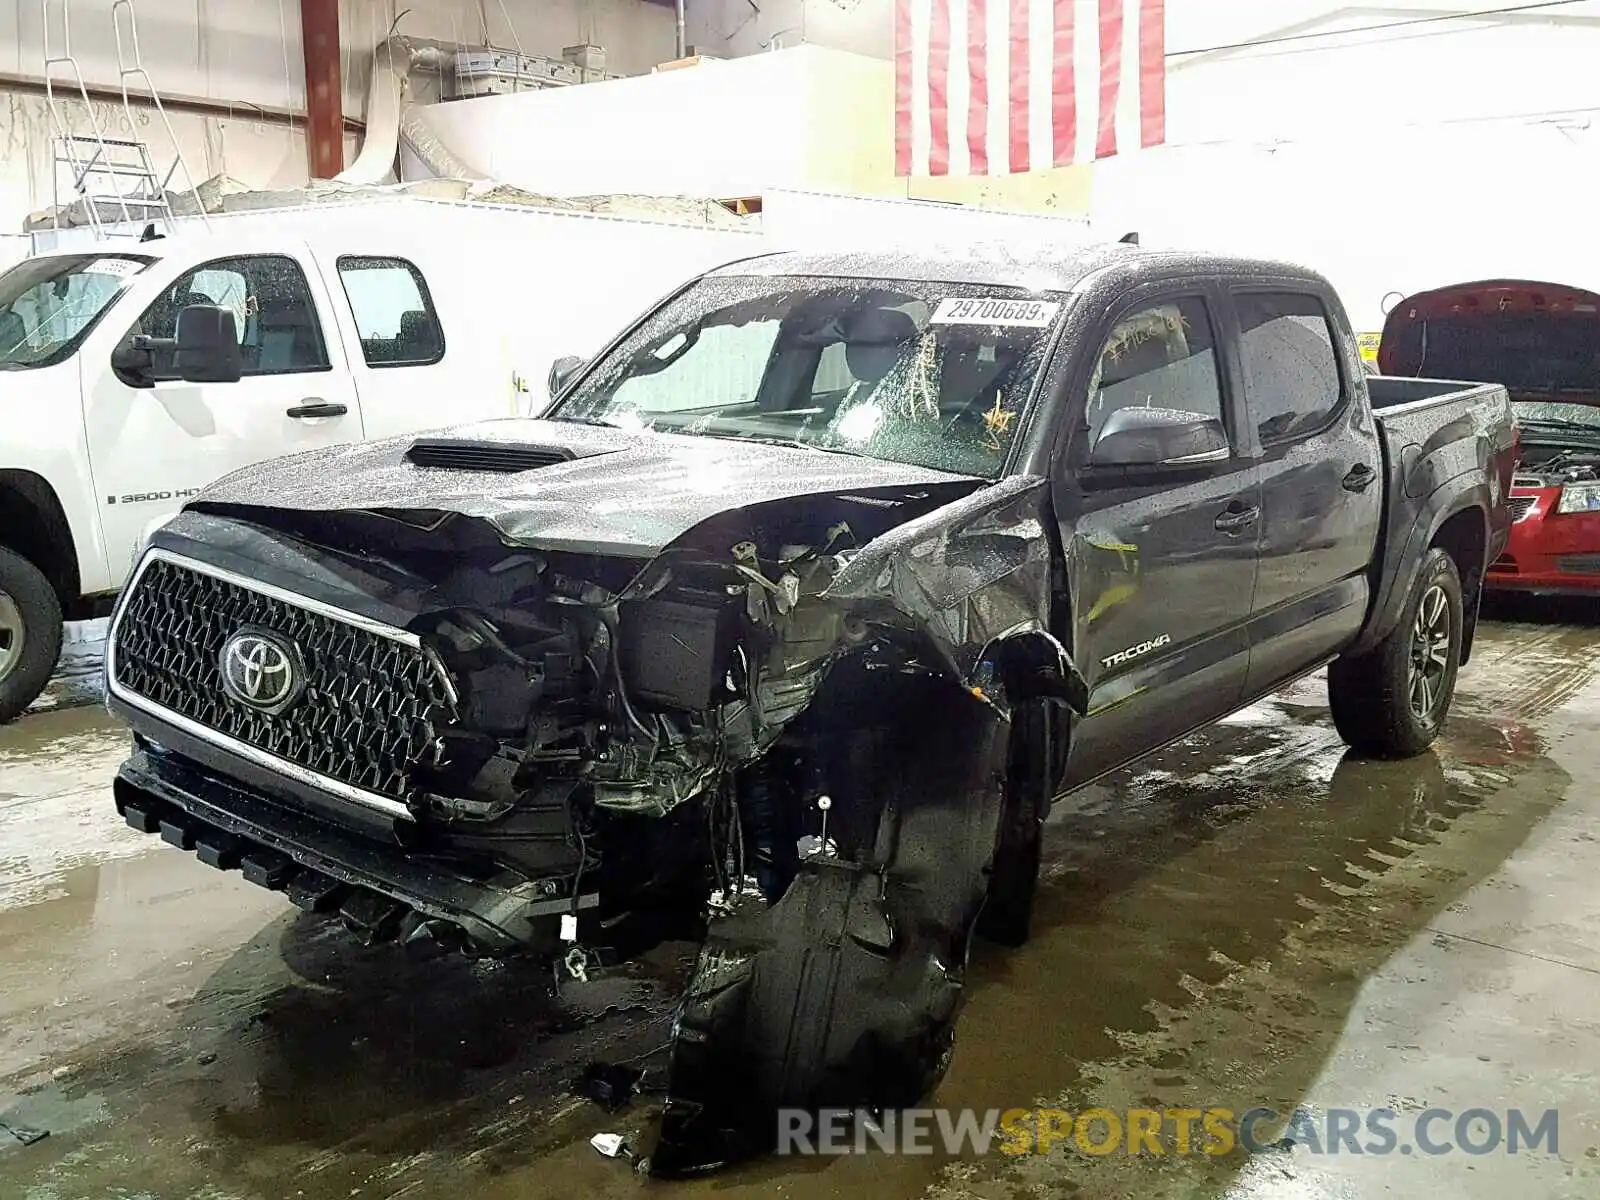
[83,253,363,578]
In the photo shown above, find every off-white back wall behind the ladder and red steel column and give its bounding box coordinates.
[0,0,675,232]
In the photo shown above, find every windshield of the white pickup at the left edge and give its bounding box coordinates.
[0,254,154,371]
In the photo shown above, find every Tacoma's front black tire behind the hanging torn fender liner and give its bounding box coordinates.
[978,701,1058,947]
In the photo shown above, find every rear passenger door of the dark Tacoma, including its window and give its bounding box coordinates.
[1232,280,1384,696]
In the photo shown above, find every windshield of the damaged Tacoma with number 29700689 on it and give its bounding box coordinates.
[547,277,1064,478]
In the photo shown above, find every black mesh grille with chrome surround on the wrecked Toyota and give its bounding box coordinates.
[107,552,456,814]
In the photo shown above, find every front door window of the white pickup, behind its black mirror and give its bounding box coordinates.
[133,254,328,379]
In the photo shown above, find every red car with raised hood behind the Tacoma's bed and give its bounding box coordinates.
[1378,280,1600,595]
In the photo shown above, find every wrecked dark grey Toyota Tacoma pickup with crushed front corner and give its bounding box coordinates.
[106,246,1514,1174]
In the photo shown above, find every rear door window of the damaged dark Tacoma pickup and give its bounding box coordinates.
[1235,291,1344,445]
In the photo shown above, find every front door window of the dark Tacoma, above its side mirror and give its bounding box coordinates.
[1088,296,1226,446]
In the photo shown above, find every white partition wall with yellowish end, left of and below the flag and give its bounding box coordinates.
[412,42,1088,214]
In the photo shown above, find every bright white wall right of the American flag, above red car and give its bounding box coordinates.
[1093,0,1600,331]
